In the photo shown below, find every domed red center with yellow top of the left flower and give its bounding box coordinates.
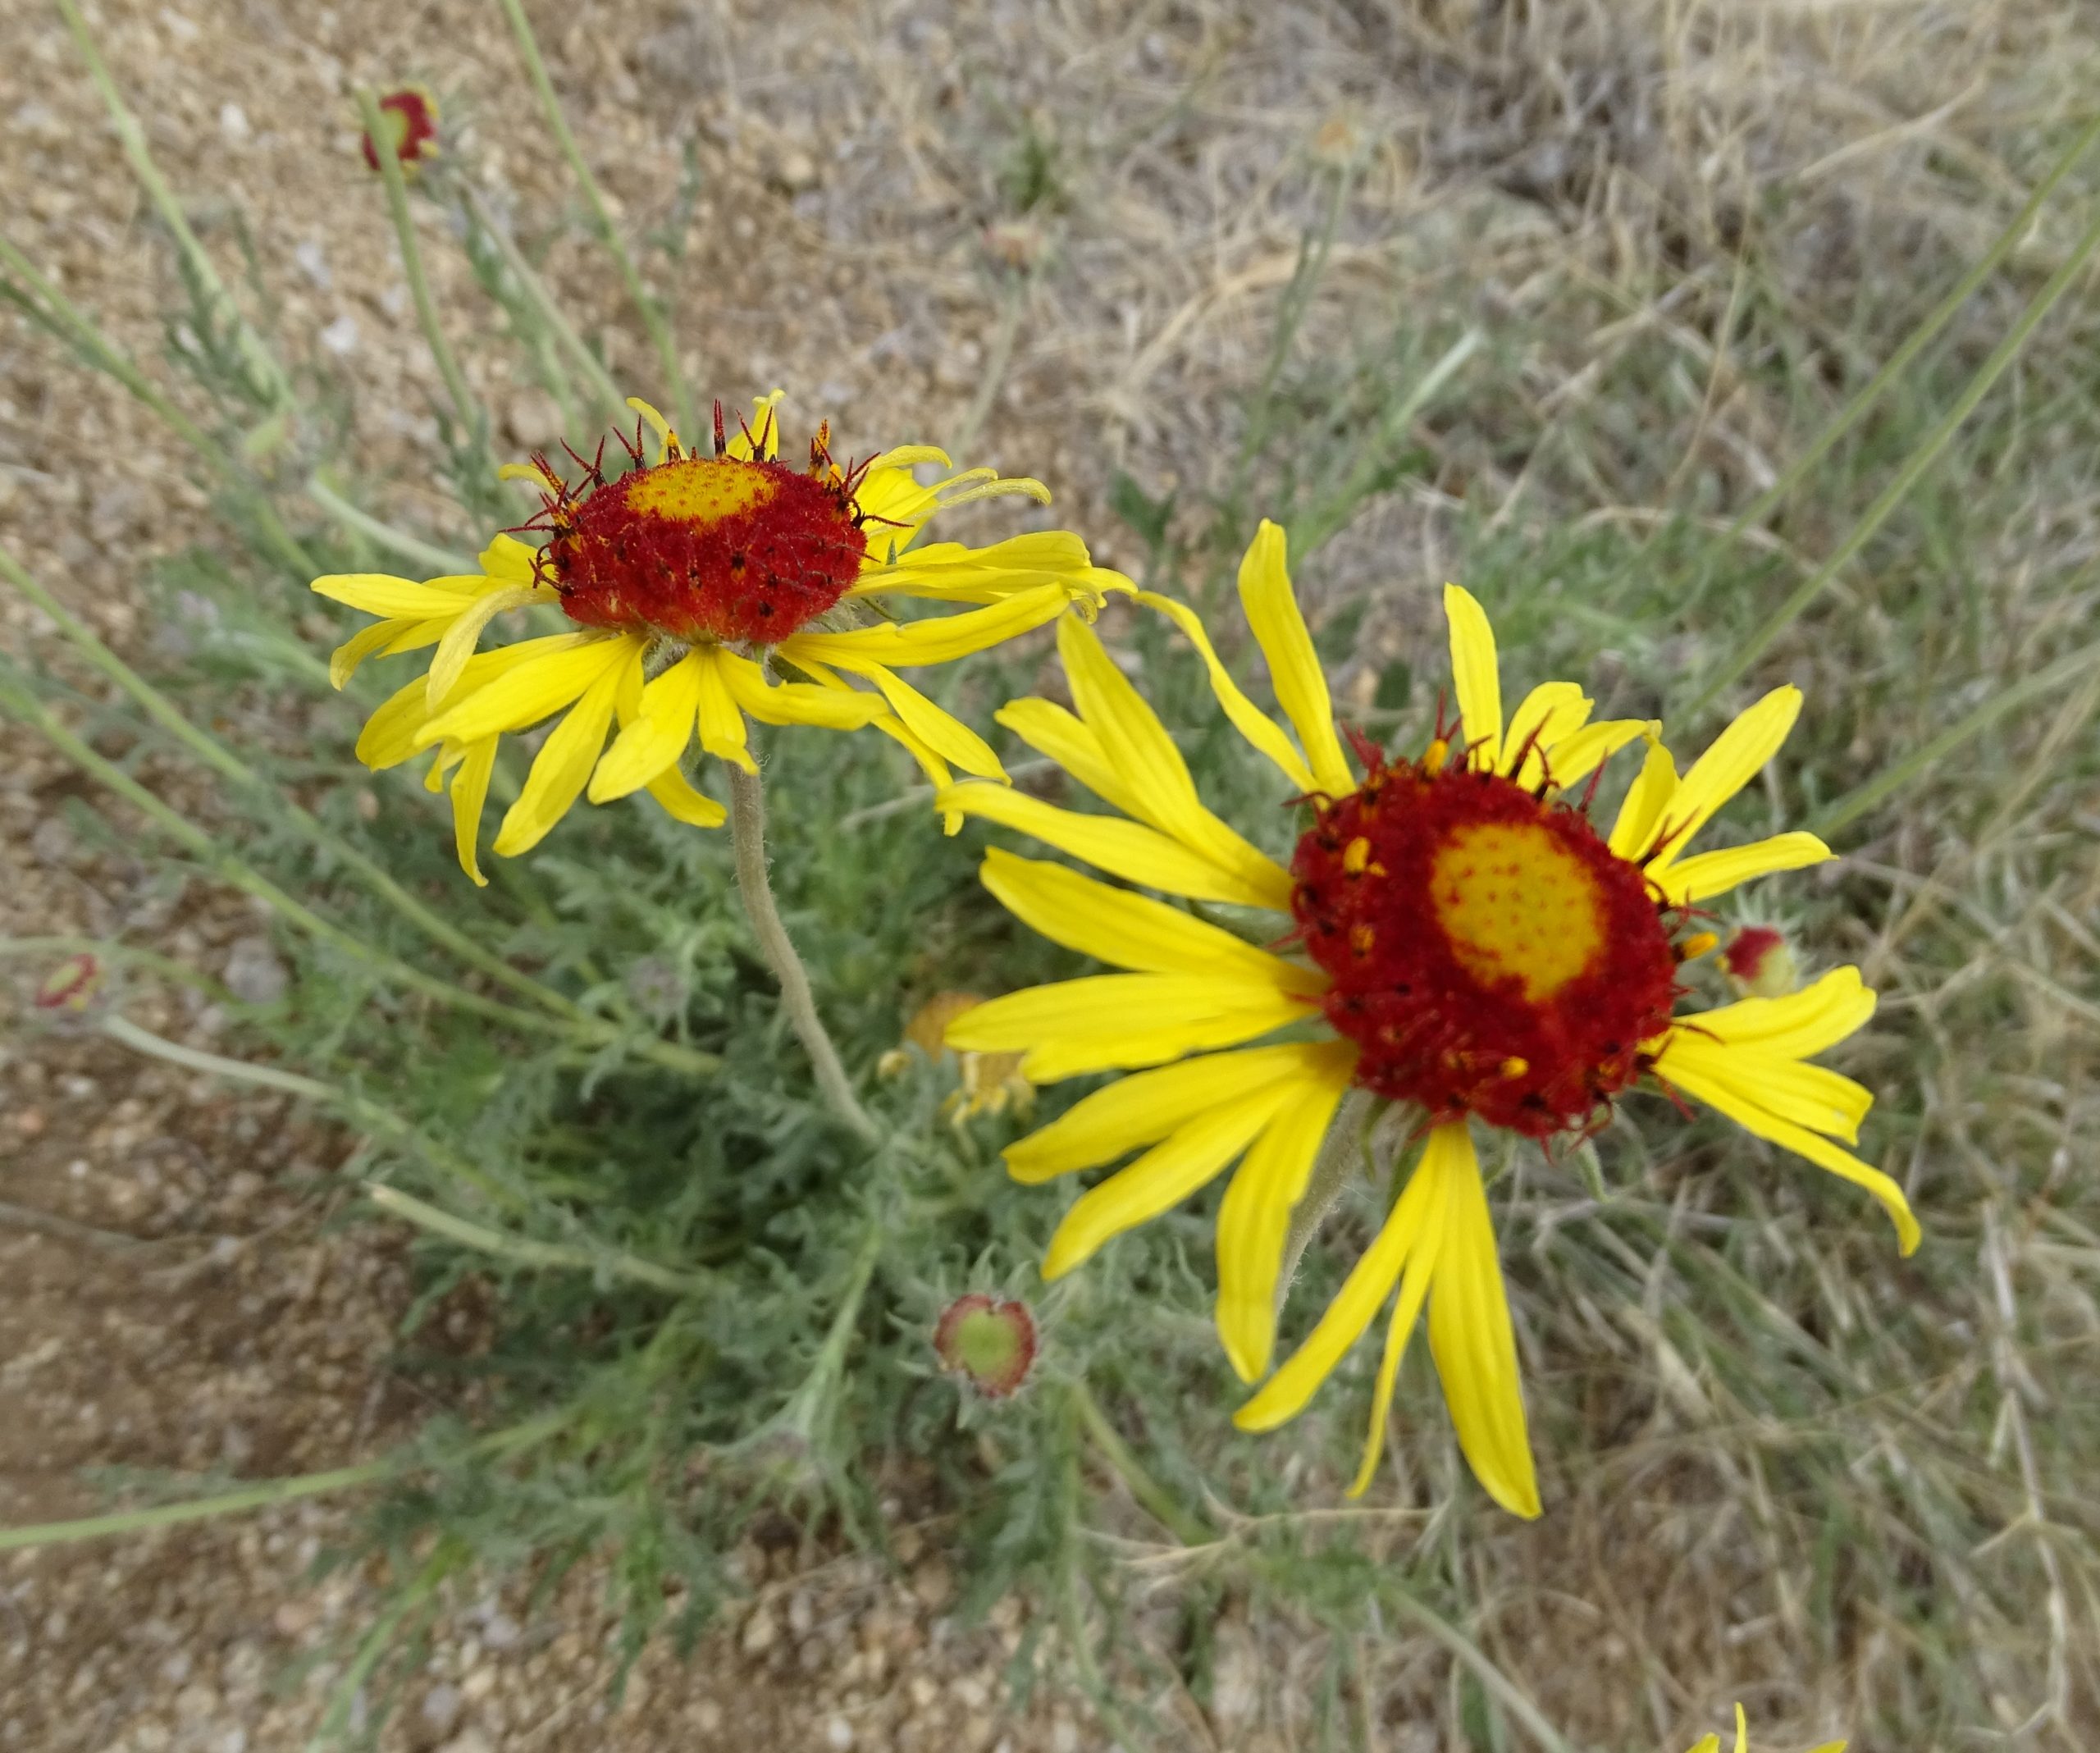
[540,419,867,645]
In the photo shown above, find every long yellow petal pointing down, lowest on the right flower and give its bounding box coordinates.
[1424,1121,1539,1518]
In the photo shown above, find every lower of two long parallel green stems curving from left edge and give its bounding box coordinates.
[0,676,723,1077]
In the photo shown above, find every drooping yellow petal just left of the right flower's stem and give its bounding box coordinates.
[1214,1041,1357,1381]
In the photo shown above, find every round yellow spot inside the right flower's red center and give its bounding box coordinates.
[1430,821,1606,1003]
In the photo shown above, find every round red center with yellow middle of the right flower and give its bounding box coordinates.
[1291,758,1678,1138]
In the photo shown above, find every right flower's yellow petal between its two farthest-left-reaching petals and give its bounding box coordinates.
[979,846,1327,995]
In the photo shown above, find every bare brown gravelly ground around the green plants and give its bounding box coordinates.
[0,0,2083,1753]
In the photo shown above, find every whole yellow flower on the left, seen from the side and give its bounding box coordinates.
[313,393,1130,883]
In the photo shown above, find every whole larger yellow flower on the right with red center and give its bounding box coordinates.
[938,523,1917,1516]
